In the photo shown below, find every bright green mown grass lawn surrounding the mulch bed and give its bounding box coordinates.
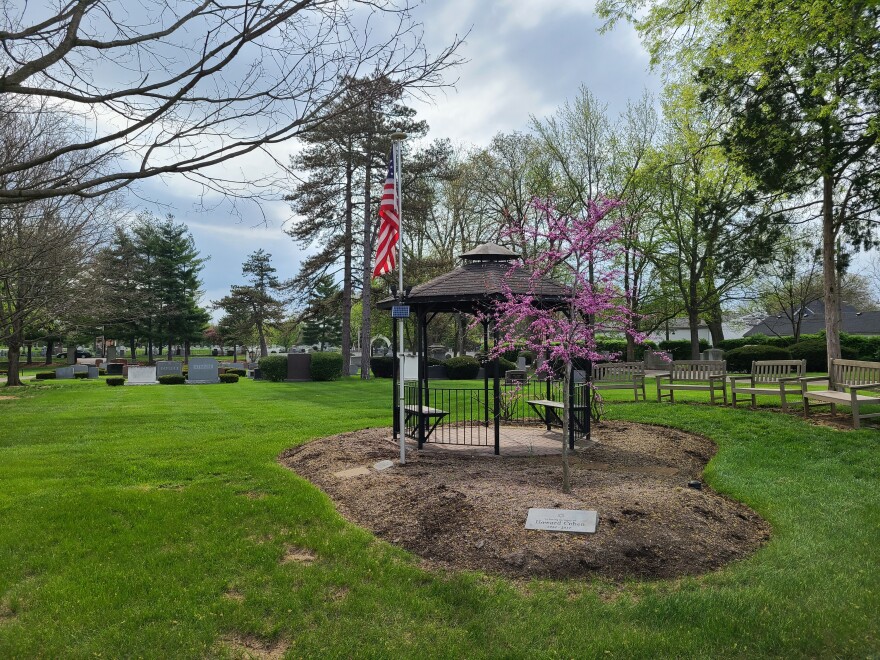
[0,380,880,658]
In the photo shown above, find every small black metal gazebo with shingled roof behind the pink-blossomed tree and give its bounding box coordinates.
[378,243,590,454]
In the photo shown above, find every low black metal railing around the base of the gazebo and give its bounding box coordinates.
[404,379,590,446]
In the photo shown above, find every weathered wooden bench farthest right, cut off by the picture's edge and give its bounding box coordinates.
[800,359,880,429]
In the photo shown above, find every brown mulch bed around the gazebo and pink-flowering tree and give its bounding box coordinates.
[280,421,770,579]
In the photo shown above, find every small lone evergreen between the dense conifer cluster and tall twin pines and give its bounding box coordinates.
[214,249,285,357]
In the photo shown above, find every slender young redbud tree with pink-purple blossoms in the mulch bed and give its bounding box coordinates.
[485,200,644,493]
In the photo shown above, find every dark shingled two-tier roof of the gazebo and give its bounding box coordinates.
[378,243,569,313]
